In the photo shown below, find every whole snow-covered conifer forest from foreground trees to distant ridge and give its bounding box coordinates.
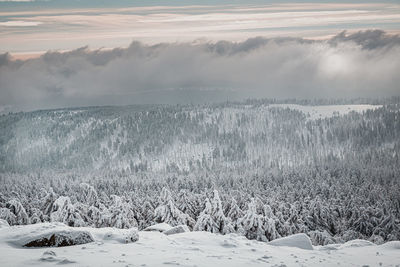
[0,98,400,245]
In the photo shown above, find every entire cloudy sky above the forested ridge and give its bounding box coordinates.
[0,0,400,109]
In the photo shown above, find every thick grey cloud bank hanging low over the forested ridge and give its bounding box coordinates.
[0,30,400,109]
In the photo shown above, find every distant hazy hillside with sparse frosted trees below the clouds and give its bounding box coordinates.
[0,103,388,173]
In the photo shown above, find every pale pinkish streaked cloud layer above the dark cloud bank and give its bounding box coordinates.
[0,0,400,53]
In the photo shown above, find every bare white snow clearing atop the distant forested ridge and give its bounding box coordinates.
[268,104,382,120]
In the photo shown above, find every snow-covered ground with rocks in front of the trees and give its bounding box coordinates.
[0,223,400,267]
